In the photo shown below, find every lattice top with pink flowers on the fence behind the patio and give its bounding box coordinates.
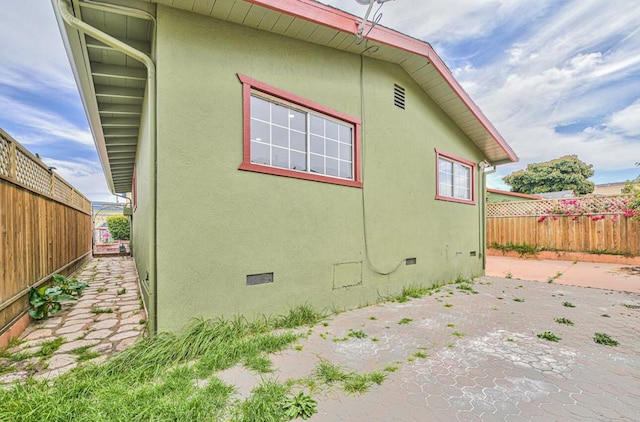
[487,195,631,217]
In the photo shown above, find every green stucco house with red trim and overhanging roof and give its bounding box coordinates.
[52,0,517,331]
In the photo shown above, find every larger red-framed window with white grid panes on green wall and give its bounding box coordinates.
[238,75,362,187]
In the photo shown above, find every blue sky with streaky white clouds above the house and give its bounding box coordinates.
[0,0,640,200]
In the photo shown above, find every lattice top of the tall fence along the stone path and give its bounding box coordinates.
[0,129,91,213]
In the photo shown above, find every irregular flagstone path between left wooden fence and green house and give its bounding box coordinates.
[0,257,147,386]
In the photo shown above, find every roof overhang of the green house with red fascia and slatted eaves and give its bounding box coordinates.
[52,0,518,193]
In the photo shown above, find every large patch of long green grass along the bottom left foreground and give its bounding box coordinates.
[0,307,328,422]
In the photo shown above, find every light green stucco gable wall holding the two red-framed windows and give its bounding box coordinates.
[156,6,484,330]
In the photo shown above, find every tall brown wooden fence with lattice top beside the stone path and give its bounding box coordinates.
[0,129,91,334]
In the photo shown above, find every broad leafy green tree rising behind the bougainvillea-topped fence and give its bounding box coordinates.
[502,155,595,195]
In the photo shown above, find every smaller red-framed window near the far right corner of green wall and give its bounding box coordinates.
[436,150,475,204]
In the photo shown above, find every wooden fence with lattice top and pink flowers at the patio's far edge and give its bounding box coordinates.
[487,196,640,256]
